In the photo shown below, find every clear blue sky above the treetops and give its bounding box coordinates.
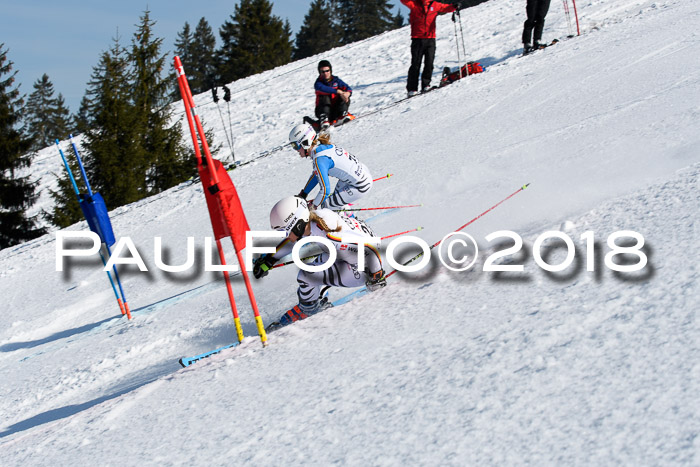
[0,0,406,112]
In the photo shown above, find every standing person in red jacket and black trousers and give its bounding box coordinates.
[401,0,457,97]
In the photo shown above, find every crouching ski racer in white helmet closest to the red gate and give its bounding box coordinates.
[253,196,386,325]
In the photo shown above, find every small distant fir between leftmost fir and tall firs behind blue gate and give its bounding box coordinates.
[25,73,69,150]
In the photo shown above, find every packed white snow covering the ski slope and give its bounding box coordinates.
[0,0,700,466]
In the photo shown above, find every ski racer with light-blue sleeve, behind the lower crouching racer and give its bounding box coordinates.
[289,124,372,210]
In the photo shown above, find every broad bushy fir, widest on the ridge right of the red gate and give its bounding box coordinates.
[217,0,292,83]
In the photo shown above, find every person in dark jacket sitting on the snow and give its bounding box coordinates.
[314,60,354,129]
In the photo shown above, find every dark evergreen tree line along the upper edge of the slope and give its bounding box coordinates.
[0,0,404,249]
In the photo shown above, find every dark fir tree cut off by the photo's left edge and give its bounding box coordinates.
[0,44,44,249]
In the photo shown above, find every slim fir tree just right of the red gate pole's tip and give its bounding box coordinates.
[189,18,216,95]
